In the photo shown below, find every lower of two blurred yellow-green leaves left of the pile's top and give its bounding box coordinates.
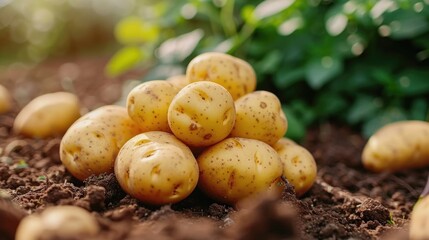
[105,47,146,76]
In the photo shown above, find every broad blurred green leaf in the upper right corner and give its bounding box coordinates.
[383,9,429,39]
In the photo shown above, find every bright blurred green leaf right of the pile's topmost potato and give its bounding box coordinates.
[306,56,343,89]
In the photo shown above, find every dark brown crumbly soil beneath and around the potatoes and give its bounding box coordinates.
[0,58,429,240]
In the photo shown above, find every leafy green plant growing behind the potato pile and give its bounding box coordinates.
[107,0,429,139]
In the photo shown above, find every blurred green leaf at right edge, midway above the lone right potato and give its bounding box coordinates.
[396,69,429,96]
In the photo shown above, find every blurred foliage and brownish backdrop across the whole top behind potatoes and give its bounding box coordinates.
[0,0,429,139]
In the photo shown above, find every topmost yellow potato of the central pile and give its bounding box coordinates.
[186,52,256,100]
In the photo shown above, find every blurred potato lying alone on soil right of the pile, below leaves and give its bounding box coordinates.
[362,121,429,172]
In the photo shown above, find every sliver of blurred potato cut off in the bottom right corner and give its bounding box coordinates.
[409,196,429,240]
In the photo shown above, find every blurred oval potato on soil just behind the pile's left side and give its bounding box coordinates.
[13,92,80,138]
